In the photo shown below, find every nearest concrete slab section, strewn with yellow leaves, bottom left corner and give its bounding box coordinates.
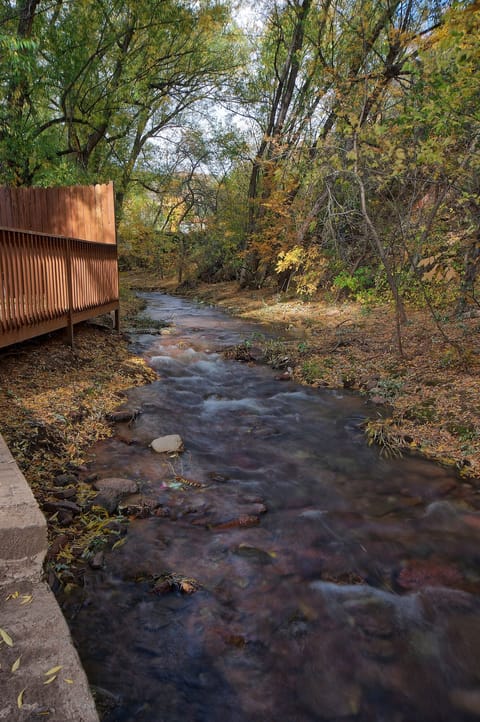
[0,581,98,722]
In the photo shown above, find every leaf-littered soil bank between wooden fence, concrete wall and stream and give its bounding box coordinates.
[0,286,156,587]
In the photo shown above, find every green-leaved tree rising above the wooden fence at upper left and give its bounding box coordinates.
[3,0,239,208]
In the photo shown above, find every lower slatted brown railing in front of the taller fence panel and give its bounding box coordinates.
[0,227,119,347]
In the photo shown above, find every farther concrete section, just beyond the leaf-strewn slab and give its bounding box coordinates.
[0,436,47,586]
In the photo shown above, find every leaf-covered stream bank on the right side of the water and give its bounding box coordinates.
[122,273,480,481]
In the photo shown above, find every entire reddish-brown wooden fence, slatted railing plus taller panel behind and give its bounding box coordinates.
[0,184,119,347]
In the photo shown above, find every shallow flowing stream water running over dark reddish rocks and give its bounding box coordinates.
[67,294,480,722]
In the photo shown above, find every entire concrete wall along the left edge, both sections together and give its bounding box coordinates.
[0,436,98,722]
